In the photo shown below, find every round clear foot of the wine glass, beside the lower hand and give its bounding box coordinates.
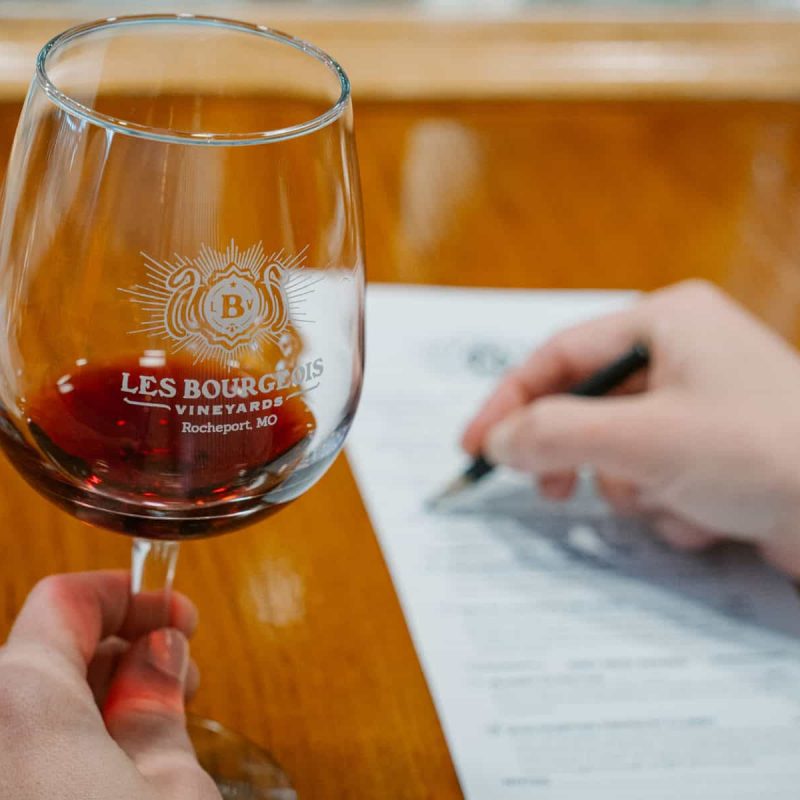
[187,714,297,800]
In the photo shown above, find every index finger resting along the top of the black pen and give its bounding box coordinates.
[462,306,646,455]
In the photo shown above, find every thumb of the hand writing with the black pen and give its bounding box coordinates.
[485,394,682,485]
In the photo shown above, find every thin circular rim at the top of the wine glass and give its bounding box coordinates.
[35,14,350,146]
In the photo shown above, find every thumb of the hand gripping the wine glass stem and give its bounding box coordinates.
[103,628,219,800]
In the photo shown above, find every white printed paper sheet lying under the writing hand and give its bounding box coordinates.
[348,286,800,800]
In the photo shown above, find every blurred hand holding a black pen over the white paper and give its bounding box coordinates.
[444,282,800,575]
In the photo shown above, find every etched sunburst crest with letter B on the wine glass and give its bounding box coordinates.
[120,241,316,363]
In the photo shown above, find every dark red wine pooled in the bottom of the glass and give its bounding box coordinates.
[0,358,327,538]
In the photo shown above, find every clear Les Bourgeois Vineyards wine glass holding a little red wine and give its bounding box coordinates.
[0,14,364,798]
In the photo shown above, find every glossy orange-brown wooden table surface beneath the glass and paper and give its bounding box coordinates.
[0,99,800,800]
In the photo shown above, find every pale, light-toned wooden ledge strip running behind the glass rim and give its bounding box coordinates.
[6,10,800,100]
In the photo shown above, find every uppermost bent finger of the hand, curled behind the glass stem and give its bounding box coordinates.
[6,571,197,677]
